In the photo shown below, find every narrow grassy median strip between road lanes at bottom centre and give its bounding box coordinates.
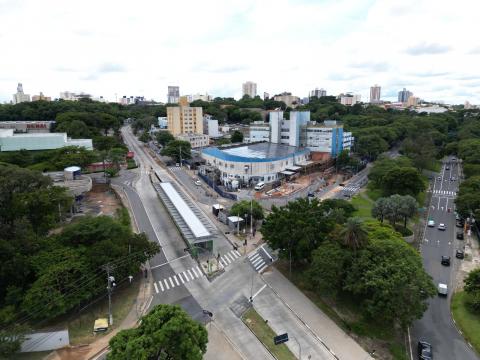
[242,308,296,360]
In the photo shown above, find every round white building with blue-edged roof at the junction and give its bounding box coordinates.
[202,142,310,185]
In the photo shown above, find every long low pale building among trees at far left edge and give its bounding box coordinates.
[0,129,93,152]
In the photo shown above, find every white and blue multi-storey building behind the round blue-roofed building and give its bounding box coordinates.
[245,111,354,157]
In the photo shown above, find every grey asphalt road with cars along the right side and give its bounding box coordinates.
[410,159,478,360]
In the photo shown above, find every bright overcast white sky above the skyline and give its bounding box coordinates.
[0,0,480,104]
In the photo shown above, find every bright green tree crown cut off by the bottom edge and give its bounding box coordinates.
[107,305,208,360]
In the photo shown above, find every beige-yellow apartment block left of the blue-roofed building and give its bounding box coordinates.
[167,96,203,137]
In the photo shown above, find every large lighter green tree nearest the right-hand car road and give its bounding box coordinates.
[344,222,436,327]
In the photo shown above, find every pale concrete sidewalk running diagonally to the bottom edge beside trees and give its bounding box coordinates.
[263,267,372,360]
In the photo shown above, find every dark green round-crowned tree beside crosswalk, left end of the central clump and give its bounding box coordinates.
[260,199,334,262]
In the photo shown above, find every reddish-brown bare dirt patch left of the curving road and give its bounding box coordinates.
[81,183,122,216]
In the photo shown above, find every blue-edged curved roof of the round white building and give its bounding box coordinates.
[202,142,309,162]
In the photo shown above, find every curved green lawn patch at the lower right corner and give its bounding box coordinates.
[450,291,480,352]
